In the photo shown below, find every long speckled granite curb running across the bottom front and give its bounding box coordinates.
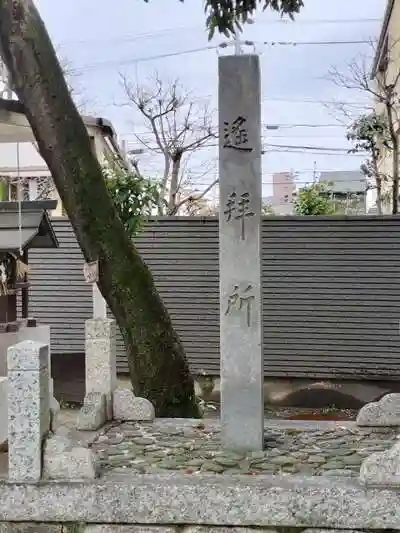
[0,474,400,529]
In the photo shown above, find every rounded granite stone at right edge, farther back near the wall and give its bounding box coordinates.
[356,393,400,427]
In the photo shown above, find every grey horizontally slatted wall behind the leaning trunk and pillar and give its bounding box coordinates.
[30,216,400,380]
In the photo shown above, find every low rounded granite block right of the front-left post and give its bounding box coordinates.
[42,427,96,481]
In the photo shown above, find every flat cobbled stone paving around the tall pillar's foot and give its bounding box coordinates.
[91,419,397,477]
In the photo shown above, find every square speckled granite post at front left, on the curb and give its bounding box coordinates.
[7,341,50,483]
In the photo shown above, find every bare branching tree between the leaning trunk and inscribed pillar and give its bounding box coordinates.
[122,74,218,215]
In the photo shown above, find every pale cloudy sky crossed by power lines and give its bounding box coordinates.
[32,0,386,196]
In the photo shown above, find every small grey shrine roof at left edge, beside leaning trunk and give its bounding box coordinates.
[0,201,59,252]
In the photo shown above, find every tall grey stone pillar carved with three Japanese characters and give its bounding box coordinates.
[219,55,264,451]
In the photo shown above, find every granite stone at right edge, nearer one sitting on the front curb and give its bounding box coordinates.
[360,443,400,487]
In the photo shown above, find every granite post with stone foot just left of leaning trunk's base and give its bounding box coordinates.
[78,318,117,430]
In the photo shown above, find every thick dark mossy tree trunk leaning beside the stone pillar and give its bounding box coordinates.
[0,0,198,416]
